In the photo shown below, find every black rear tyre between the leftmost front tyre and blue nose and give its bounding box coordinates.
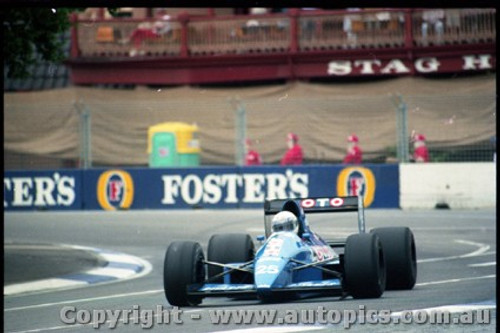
[207,233,255,283]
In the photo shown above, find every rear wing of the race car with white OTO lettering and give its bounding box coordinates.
[264,196,365,234]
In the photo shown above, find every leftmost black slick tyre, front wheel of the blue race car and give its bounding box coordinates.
[163,241,205,306]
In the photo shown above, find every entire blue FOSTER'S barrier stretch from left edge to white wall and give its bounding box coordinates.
[4,164,400,211]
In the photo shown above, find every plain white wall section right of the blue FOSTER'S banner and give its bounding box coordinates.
[399,162,496,209]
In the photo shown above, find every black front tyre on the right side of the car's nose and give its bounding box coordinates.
[344,233,386,298]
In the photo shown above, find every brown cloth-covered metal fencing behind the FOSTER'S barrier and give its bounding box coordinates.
[4,86,496,170]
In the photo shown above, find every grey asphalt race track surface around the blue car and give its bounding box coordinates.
[4,209,496,332]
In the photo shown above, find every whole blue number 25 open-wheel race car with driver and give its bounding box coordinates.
[163,196,417,306]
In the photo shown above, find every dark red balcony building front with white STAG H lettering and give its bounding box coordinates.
[67,8,496,85]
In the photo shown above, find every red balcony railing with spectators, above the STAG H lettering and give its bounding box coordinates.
[72,8,496,58]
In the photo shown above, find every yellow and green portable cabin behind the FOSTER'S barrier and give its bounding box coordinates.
[148,122,201,167]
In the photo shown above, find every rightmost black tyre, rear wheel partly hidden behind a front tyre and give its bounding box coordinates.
[371,227,417,290]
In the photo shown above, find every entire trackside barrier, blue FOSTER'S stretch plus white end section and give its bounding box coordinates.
[4,162,496,211]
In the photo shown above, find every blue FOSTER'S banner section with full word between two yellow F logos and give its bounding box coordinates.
[83,164,399,210]
